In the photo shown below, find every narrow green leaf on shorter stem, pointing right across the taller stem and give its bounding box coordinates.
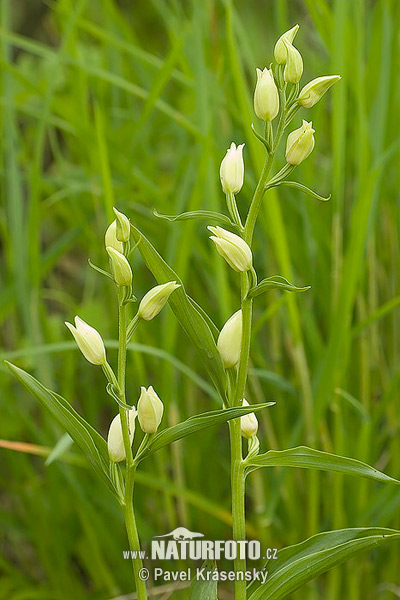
[140,402,275,459]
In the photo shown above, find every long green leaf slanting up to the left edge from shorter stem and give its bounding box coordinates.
[5,361,115,492]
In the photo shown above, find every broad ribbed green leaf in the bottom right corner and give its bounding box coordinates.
[249,527,400,600]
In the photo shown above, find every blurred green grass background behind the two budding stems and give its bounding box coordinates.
[0,0,400,600]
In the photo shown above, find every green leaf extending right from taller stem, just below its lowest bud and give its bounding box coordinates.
[248,446,400,484]
